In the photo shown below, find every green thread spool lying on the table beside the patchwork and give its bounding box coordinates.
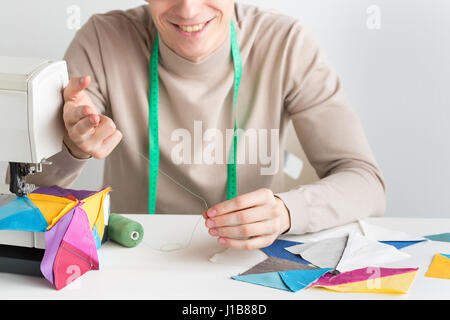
[108,213,144,248]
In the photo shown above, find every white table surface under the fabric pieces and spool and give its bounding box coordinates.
[0,215,450,300]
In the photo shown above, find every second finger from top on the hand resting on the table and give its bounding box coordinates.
[205,205,276,228]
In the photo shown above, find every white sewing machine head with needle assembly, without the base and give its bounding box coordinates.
[0,56,69,196]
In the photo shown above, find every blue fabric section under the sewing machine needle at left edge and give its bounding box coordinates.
[0,197,48,232]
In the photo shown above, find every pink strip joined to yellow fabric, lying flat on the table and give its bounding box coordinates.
[311,267,418,287]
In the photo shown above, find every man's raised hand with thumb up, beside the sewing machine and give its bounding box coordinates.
[63,76,122,159]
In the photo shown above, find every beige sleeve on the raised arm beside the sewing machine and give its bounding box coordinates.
[6,18,108,188]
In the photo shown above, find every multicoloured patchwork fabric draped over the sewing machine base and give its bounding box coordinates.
[0,186,111,290]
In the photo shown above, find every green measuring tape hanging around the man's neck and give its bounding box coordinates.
[148,22,242,214]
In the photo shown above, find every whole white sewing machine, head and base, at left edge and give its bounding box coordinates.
[0,56,69,275]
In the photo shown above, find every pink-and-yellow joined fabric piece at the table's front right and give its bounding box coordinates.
[311,267,419,293]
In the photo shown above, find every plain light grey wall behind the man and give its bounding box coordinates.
[0,0,450,217]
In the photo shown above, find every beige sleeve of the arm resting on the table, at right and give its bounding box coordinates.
[277,28,385,234]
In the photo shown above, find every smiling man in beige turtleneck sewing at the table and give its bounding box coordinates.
[27,0,385,249]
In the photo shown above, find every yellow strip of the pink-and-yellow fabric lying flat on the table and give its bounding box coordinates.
[317,271,417,294]
